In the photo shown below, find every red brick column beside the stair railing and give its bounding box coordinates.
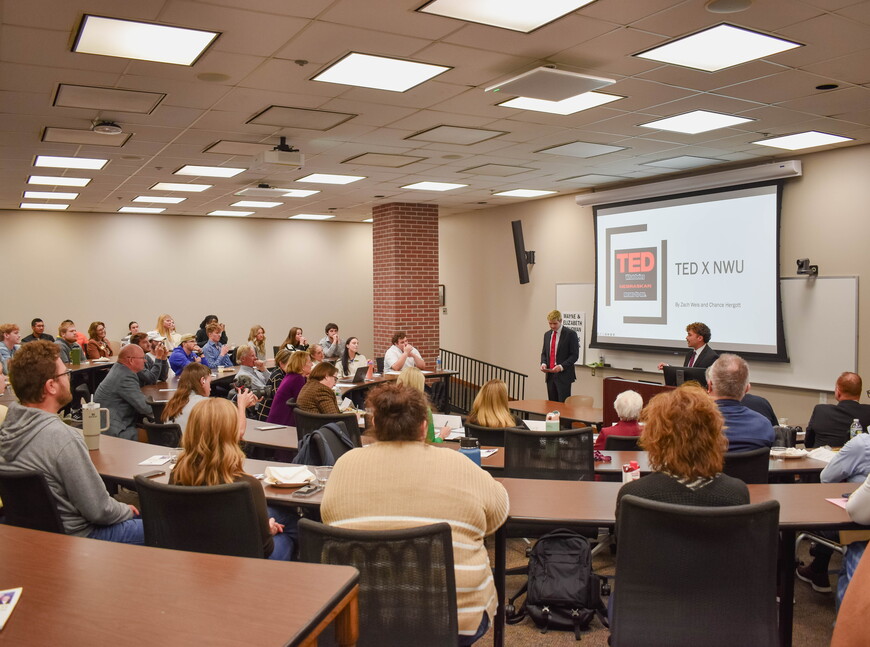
[372,202,440,366]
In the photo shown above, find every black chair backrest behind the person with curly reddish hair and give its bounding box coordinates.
[610,495,779,647]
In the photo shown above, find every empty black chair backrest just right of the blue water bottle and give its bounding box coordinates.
[504,427,595,481]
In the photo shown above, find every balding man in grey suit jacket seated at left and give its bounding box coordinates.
[94,344,152,440]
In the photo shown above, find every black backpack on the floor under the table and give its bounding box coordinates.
[505,528,608,640]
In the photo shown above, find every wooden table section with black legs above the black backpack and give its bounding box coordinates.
[493,479,861,647]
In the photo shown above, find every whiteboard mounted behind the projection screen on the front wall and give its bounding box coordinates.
[556,276,858,391]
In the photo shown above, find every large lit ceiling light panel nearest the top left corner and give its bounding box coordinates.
[72,15,219,65]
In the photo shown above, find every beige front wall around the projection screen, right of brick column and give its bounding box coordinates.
[441,146,870,425]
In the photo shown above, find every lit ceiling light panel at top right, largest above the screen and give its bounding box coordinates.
[635,23,801,72]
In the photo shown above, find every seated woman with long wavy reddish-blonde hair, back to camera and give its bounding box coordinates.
[169,398,293,560]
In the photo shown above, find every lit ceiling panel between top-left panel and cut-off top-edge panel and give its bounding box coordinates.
[311,52,450,92]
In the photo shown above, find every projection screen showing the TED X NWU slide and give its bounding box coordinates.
[591,183,785,360]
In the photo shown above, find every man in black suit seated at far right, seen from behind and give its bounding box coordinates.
[805,372,870,447]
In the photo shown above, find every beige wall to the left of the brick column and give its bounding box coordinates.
[0,211,372,356]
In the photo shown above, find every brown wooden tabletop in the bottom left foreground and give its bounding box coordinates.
[0,525,359,647]
